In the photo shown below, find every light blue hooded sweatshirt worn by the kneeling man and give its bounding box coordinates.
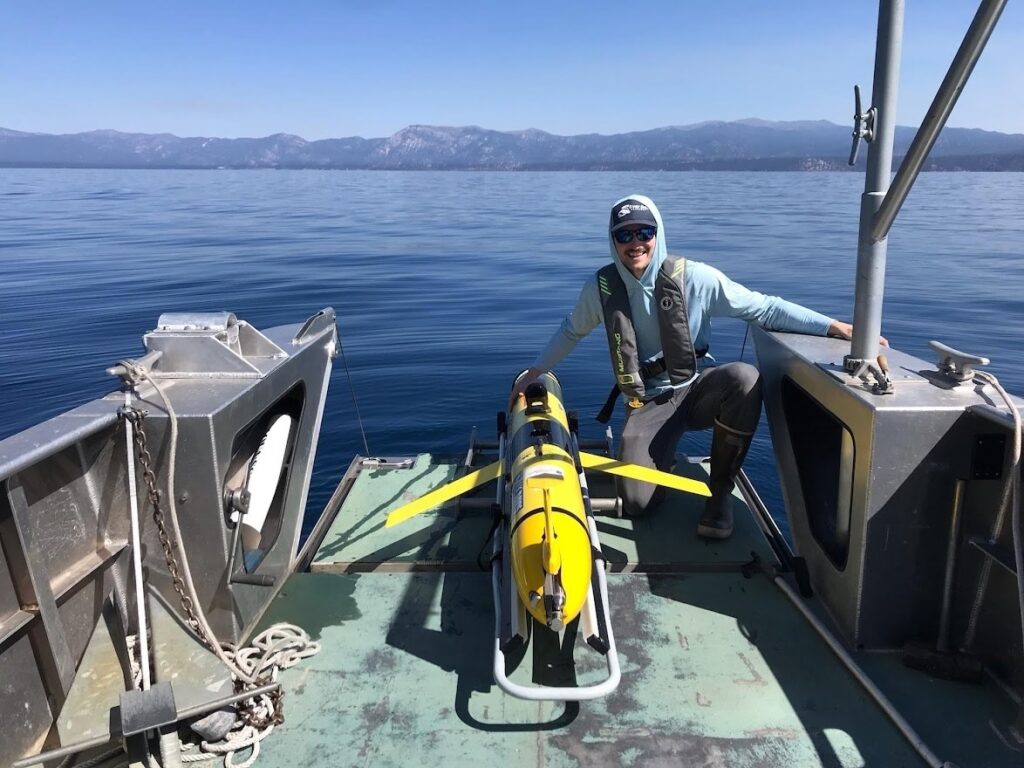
[532,195,831,396]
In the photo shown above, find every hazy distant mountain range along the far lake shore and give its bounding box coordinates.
[0,119,1024,171]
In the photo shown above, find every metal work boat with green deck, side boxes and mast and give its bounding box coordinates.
[0,0,1024,768]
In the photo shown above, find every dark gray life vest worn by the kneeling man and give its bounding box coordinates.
[597,256,708,399]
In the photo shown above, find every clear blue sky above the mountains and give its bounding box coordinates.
[0,0,1024,139]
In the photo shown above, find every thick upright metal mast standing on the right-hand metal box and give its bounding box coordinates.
[846,0,903,370]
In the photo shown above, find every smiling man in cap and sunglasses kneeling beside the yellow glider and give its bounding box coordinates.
[513,195,853,539]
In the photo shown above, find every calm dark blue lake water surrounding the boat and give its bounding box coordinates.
[0,169,1024,536]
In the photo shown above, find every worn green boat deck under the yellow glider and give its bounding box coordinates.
[249,455,1024,768]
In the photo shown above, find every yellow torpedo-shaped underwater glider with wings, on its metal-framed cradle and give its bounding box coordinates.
[386,373,711,701]
